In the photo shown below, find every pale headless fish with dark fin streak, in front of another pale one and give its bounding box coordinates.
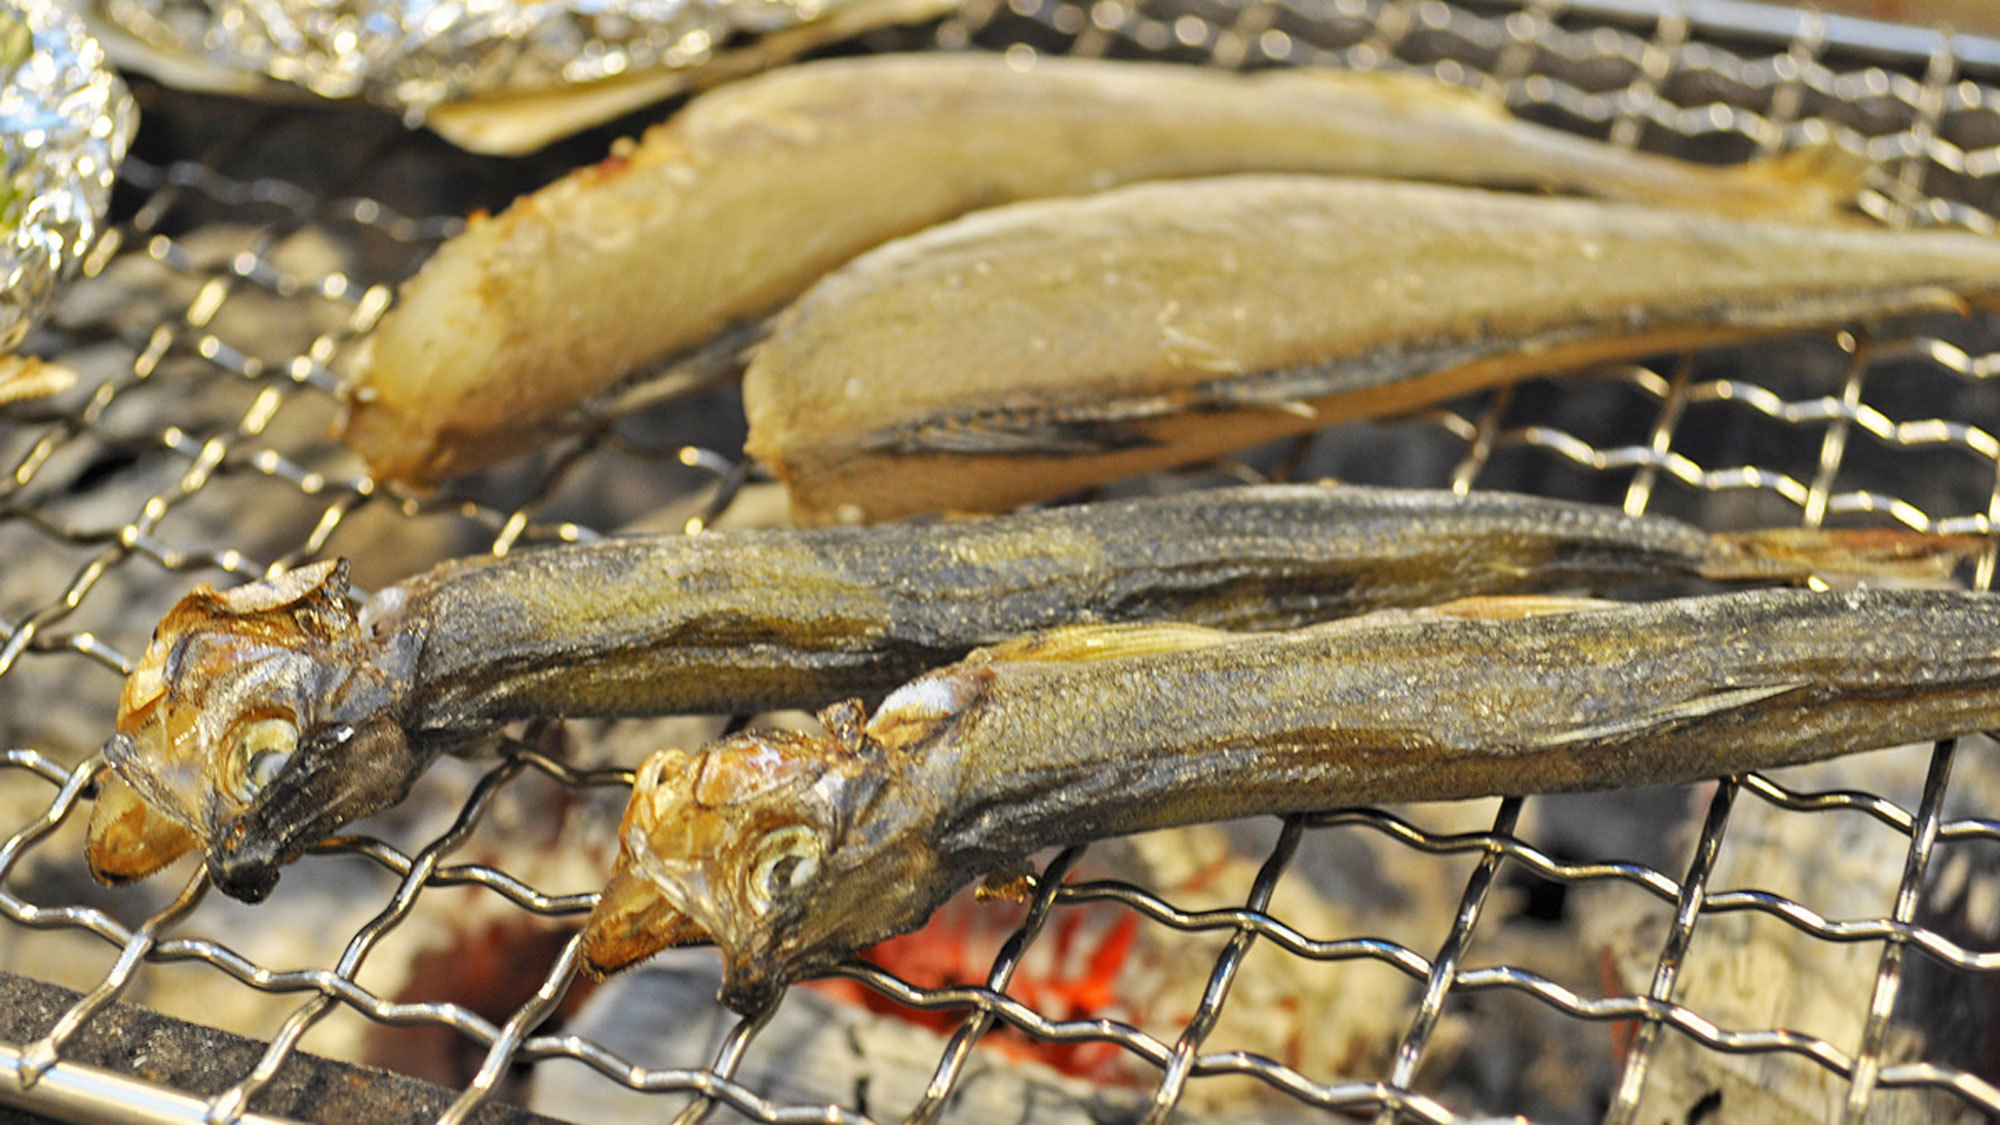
[744,176,2000,522]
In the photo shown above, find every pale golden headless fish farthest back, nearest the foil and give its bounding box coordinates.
[346,54,1858,484]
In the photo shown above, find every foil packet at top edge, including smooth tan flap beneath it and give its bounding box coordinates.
[94,0,950,152]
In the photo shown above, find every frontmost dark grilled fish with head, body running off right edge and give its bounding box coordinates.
[584,591,2000,1011]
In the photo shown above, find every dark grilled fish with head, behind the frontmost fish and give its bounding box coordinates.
[74,484,1984,899]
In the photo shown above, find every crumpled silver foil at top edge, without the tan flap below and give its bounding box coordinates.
[98,0,876,122]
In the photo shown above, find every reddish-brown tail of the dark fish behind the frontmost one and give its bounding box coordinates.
[1700,526,1992,583]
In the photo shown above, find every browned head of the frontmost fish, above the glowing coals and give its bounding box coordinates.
[584,705,950,1013]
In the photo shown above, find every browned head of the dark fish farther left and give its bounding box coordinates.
[86,560,402,901]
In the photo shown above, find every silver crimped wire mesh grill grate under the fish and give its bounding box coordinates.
[0,0,2000,1123]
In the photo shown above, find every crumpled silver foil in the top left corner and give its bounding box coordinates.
[0,0,138,352]
